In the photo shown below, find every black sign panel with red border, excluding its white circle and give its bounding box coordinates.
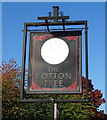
[28,31,82,94]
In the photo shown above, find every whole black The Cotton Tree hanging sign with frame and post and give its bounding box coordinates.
[20,6,89,120]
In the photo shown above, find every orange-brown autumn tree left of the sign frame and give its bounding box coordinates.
[0,59,23,119]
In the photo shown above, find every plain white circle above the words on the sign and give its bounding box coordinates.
[41,38,69,65]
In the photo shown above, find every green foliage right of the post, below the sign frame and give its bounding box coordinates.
[61,103,91,120]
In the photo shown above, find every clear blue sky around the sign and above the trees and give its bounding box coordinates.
[2,2,105,113]
